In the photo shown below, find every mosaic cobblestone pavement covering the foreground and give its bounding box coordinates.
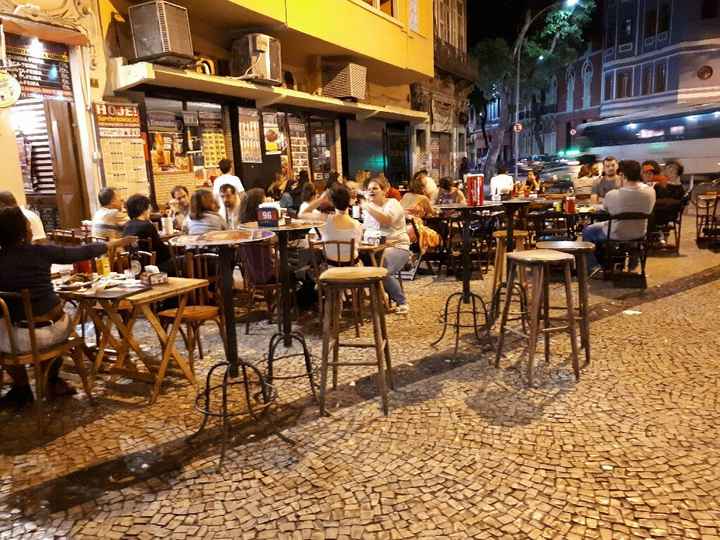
[0,214,720,538]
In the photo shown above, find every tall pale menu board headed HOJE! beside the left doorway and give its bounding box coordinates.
[93,103,150,195]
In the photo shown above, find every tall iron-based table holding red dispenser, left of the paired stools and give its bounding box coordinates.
[432,201,501,354]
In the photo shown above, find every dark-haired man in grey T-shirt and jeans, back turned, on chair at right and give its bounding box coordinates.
[583,160,655,276]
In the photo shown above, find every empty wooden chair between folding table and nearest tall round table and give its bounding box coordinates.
[158,251,225,367]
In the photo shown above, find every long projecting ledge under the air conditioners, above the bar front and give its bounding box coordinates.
[111,59,428,124]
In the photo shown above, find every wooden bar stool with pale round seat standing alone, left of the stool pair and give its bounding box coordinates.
[319,266,395,416]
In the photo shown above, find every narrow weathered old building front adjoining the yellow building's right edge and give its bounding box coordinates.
[412,0,478,178]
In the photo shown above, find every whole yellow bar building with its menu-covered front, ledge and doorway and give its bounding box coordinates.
[0,0,434,229]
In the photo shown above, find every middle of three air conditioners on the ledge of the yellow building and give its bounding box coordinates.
[230,34,282,85]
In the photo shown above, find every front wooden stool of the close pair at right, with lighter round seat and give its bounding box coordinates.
[495,249,580,386]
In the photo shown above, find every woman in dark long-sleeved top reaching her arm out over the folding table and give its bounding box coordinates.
[0,207,137,408]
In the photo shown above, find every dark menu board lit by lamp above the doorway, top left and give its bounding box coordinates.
[6,34,72,99]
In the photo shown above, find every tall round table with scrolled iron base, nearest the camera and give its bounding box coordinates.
[170,230,293,468]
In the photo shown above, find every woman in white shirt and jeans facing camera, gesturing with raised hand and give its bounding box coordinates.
[362,177,410,314]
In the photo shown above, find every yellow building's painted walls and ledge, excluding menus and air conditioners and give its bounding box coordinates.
[0,0,434,226]
